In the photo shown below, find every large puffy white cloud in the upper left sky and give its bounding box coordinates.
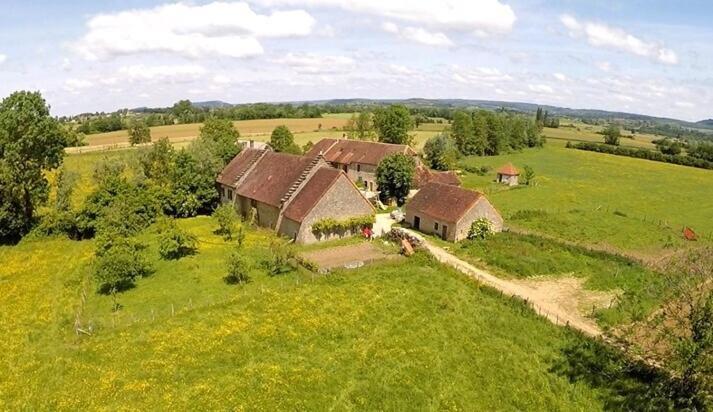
[73,2,315,60]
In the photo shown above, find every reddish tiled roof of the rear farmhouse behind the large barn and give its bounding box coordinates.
[307,139,416,166]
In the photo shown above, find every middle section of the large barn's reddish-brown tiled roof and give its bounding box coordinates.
[236,152,313,207]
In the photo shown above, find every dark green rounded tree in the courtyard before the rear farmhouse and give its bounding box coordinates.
[376,153,416,205]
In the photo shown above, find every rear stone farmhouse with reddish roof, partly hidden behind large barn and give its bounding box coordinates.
[306,139,419,192]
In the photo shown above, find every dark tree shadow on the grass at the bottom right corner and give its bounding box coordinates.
[550,336,700,411]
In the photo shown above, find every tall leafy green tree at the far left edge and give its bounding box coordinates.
[0,91,66,238]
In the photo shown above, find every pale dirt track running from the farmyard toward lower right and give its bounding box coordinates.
[406,229,602,337]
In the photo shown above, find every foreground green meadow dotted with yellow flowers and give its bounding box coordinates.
[0,218,602,410]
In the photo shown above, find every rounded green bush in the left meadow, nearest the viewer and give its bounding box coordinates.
[94,238,151,294]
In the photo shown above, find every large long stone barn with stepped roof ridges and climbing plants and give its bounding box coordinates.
[217,148,374,243]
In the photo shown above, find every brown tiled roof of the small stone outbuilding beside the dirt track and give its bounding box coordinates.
[406,182,483,223]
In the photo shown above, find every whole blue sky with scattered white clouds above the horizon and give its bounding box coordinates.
[0,0,713,120]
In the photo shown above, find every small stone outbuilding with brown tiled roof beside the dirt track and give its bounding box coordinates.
[406,182,503,242]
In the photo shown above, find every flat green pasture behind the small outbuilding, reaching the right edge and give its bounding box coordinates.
[456,142,713,254]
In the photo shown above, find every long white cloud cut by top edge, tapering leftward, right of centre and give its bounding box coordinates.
[253,0,516,36]
